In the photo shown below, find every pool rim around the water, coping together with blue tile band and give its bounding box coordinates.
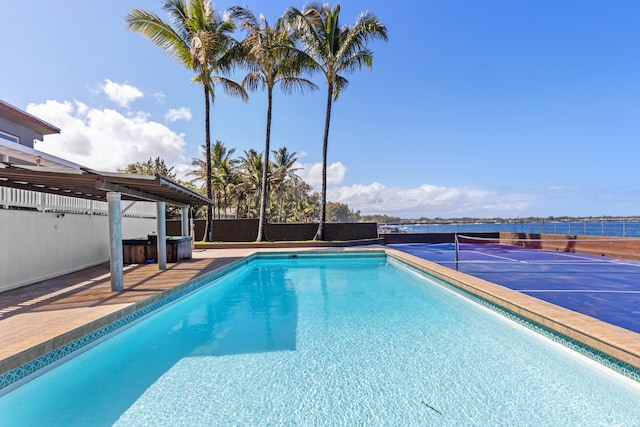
[0,247,640,394]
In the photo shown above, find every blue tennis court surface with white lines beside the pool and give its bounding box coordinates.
[389,243,640,333]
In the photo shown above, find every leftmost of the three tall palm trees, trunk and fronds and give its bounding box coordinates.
[125,0,247,241]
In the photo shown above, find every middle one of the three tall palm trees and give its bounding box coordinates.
[231,6,317,242]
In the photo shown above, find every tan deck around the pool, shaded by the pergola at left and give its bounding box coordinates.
[0,245,640,382]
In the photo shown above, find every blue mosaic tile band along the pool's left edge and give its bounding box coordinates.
[0,257,246,394]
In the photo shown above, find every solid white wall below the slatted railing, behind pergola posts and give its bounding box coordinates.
[0,208,157,292]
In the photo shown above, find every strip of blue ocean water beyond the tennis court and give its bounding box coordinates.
[393,221,640,237]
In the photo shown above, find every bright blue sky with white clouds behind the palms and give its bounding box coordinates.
[0,0,640,218]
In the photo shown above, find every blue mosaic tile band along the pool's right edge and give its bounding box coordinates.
[390,257,640,382]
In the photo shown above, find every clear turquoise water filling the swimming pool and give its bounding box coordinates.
[0,252,640,426]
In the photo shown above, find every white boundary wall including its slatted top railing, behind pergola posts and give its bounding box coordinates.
[0,187,157,292]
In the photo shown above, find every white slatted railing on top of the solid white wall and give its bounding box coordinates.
[0,187,157,218]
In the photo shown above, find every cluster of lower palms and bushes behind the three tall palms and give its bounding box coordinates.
[118,153,378,223]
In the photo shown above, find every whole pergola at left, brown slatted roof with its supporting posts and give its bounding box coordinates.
[0,162,213,291]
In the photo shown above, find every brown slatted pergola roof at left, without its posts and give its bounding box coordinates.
[0,163,213,205]
